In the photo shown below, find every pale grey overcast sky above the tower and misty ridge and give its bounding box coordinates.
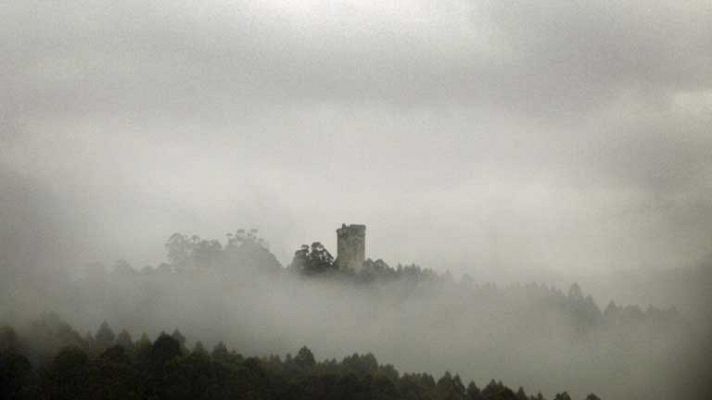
[0,0,712,272]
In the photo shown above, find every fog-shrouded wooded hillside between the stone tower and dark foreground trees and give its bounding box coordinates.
[0,230,712,400]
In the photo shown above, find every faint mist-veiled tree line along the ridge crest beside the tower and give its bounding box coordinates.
[76,229,678,332]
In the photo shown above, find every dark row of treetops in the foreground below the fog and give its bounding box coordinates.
[0,315,598,400]
